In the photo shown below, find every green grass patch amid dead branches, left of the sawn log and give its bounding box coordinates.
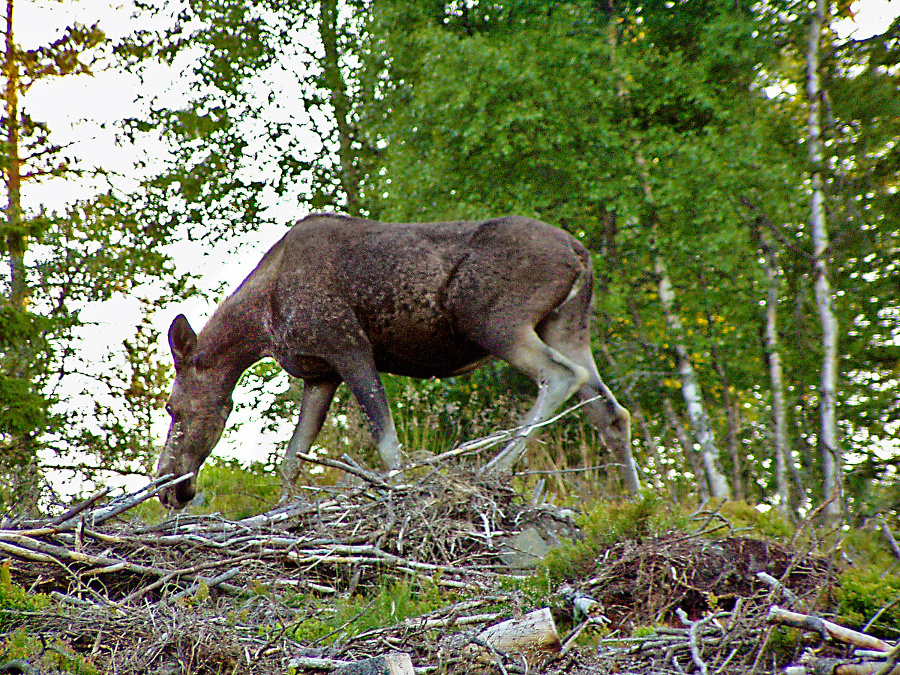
[293,581,455,644]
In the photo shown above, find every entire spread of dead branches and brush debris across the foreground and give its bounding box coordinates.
[0,471,890,675]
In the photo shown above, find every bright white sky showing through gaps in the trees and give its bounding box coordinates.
[14,0,900,488]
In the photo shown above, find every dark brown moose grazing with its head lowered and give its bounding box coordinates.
[158,214,639,508]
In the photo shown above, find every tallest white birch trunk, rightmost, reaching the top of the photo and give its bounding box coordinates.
[806,0,843,520]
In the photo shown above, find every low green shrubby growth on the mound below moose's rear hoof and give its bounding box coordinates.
[545,494,688,582]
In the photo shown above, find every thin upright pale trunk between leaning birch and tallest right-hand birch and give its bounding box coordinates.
[759,229,791,516]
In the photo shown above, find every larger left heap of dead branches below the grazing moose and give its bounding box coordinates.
[0,473,571,673]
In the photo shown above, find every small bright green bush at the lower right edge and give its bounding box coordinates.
[837,568,900,640]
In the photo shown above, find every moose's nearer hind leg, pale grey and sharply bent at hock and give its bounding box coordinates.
[481,329,589,473]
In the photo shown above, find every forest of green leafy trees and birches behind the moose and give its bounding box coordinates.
[0,0,900,519]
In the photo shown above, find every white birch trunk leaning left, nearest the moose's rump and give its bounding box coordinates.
[653,252,731,499]
